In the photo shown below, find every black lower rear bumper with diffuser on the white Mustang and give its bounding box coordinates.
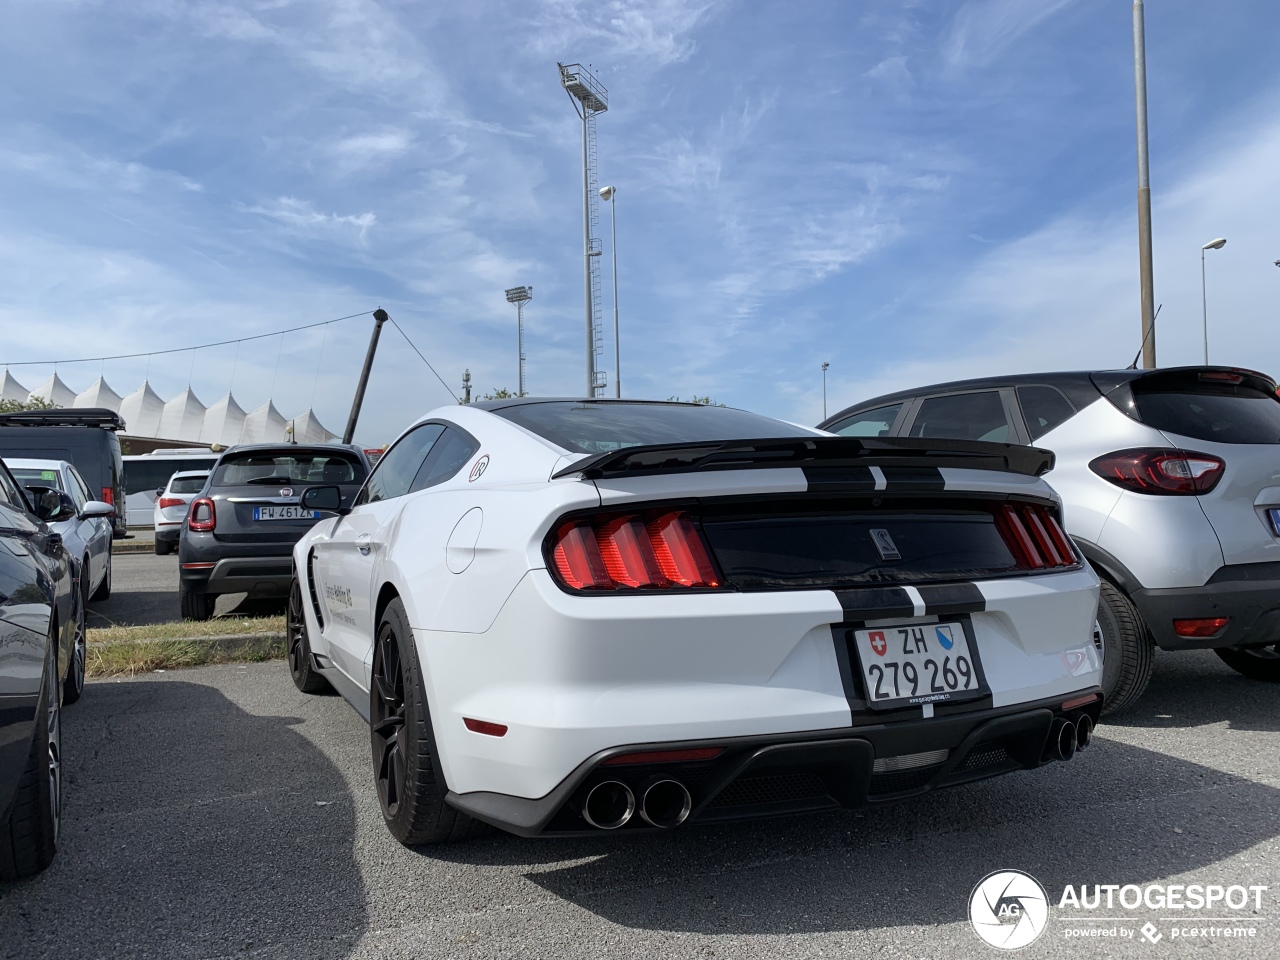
[447,687,1102,837]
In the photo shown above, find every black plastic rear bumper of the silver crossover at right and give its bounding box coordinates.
[1132,563,1280,650]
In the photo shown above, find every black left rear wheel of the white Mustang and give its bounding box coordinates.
[369,598,488,846]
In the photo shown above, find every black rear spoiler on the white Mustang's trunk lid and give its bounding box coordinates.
[552,436,1053,480]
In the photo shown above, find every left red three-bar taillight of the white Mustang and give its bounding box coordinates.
[548,511,723,591]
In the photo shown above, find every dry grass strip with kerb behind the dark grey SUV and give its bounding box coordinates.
[84,617,284,677]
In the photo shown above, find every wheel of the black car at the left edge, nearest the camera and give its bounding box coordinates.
[0,630,63,881]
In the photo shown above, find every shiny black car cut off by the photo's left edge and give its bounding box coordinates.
[0,463,84,881]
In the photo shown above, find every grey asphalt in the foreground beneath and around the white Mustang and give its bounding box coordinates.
[0,650,1280,957]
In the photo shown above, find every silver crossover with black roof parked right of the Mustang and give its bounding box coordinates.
[820,366,1280,713]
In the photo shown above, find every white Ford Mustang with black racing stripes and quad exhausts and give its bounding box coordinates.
[288,398,1102,845]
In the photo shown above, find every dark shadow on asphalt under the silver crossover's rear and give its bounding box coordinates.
[1103,650,1280,732]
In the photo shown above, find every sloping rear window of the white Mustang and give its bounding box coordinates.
[493,401,824,453]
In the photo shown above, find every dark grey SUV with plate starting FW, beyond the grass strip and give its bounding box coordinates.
[178,443,369,620]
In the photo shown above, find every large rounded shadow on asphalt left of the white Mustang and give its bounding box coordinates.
[0,678,367,957]
